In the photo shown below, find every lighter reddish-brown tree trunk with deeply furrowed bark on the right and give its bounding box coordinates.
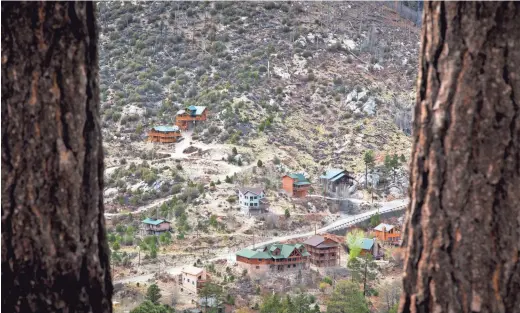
[399,2,520,313]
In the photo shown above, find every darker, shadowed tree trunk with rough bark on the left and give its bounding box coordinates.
[2,2,112,312]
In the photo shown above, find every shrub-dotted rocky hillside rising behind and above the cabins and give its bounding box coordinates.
[98,1,419,174]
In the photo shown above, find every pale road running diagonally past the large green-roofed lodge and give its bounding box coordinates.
[115,199,408,284]
